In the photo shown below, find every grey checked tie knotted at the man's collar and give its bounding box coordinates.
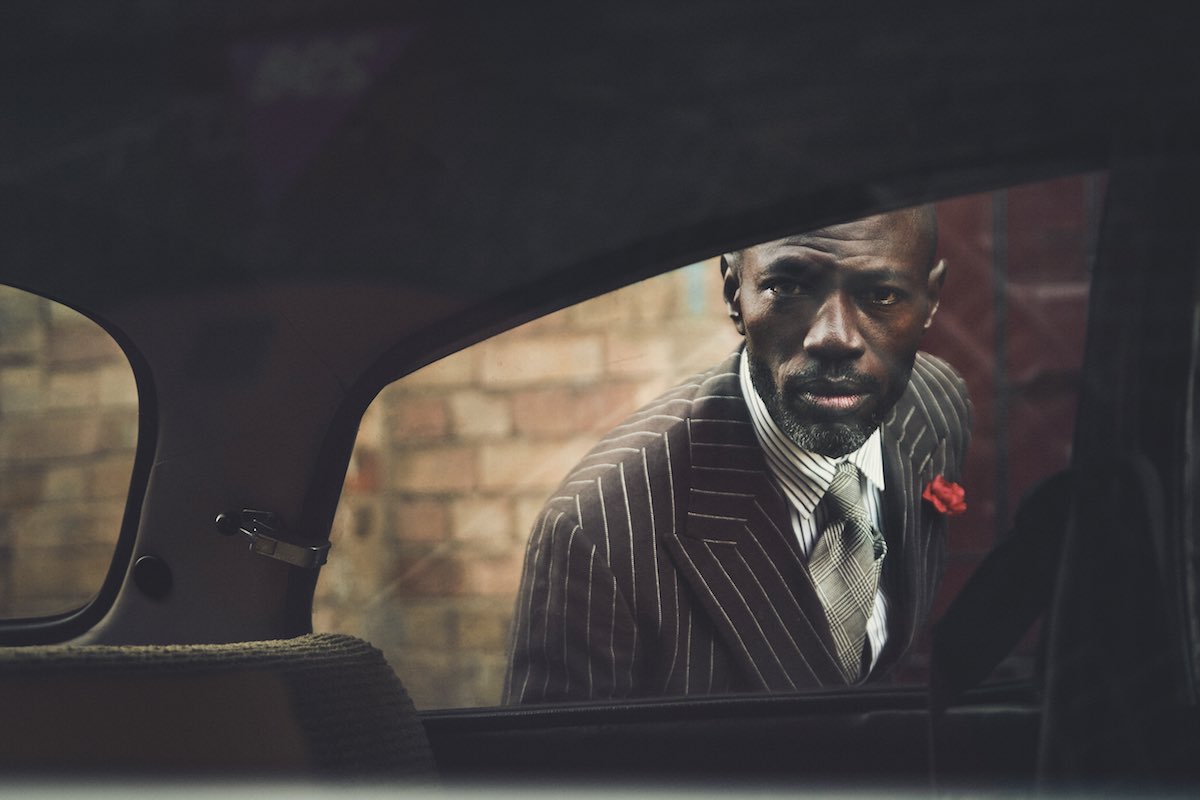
[809,462,888,684]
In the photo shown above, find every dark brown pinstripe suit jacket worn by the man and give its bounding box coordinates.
[504,351,971,703]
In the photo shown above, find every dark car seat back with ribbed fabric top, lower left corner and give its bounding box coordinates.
[0,634,437,780]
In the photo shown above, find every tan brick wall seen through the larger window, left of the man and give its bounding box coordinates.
[314,260,740,708]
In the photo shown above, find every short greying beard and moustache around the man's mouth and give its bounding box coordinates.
[745,350,912,458]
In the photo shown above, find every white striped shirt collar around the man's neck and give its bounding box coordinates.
[738,348,883,519]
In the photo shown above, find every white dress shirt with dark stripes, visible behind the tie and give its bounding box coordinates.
[738,359,888,680]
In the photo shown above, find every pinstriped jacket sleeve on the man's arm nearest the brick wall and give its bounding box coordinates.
[503,501,636,704]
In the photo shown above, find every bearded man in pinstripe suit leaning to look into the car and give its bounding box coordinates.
[505,207,970,703]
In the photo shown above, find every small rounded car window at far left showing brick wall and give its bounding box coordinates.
[0,287,138,619]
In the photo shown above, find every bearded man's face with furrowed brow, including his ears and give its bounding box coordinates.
[725,210,946,457]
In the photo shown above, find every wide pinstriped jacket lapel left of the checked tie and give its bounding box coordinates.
[666,356,841,691]
